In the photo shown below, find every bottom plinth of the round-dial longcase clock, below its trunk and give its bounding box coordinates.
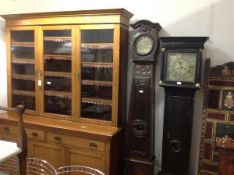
[124,157,155,175]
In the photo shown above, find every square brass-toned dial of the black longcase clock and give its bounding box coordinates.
[166,53,197,83]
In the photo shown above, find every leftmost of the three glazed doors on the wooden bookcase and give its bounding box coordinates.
[7,27,39,115]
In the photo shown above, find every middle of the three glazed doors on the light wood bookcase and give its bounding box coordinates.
[38,26,75,120]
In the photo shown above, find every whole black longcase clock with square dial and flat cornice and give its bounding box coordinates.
[159,37,208,175]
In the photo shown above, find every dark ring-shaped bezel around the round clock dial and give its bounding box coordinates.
[132,33,157,56]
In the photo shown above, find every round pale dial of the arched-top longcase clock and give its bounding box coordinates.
[134,35,154,55]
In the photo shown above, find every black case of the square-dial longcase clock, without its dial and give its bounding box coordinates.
[158,37,208,175]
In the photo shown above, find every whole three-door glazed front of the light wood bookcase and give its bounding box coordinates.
[7,24,121,126]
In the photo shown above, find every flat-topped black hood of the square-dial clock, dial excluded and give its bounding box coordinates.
[159,37,208,89]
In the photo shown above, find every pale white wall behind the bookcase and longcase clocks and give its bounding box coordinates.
[0,0,234,175]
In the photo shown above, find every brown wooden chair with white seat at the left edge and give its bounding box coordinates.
[0,105,27,175]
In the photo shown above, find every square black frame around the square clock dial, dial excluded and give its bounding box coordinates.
[161,49,202,88]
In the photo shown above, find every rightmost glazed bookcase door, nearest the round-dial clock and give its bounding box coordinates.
[78,25,118,125]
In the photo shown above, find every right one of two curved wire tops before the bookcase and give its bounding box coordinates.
[57,165,105,175]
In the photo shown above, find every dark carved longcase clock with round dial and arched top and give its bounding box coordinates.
[124,20,161,175]
